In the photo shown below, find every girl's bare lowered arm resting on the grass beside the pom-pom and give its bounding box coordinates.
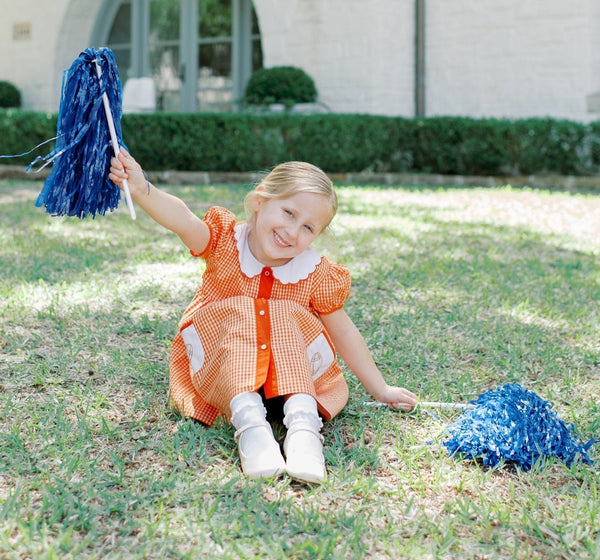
[321,309,417,412]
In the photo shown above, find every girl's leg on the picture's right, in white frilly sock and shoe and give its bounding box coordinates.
[283,393,326,482]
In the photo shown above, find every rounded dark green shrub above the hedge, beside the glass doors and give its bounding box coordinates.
[245,66,317,107]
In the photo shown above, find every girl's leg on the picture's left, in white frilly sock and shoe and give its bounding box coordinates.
[230,393,285,478]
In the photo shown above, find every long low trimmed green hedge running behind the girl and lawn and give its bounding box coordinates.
[0,110,600,175]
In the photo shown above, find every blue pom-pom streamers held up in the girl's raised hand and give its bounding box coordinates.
[29,48,122,218]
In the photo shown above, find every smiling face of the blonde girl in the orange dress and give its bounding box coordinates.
[248,188,332,267]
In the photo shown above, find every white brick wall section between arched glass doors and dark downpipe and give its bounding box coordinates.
[254,0,414,115]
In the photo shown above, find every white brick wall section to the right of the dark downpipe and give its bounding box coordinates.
[426,0,597,118]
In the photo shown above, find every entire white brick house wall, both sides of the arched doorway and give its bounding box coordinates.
[0,0,600,120]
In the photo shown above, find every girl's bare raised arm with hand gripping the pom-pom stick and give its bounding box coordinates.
[109,149,210,254]
